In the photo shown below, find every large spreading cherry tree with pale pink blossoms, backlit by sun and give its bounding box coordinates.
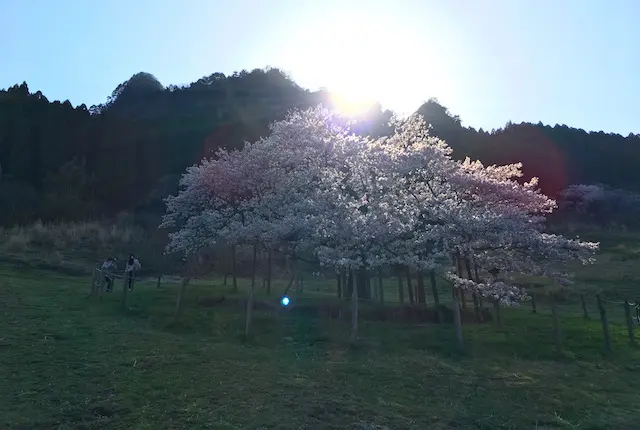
[163,107,597,348]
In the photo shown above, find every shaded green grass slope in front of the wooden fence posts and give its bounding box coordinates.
[0,266,640,429]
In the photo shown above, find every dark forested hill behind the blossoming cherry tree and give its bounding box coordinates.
[0,69,640,225]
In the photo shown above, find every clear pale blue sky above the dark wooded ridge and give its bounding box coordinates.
[0,0,640,135]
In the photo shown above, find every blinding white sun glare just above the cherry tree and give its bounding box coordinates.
[290,11,429,114]
